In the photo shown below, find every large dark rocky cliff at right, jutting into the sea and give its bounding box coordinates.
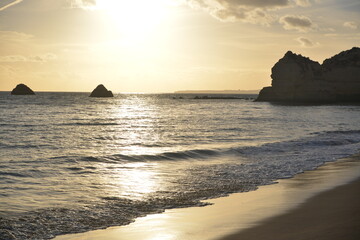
[256,47,360,103]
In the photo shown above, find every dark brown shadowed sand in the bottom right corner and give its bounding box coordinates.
[221,176,360,240]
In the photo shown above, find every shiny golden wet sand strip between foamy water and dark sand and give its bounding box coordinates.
[55,154,360,240]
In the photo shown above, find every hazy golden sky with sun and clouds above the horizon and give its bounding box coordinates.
[0,0,360,93]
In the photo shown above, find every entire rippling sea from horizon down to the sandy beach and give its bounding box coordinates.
[0,92,360,239]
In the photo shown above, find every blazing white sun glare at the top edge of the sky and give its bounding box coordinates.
[96,0,168,37]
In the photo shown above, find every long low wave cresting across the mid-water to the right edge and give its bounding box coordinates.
[74,130,360,162]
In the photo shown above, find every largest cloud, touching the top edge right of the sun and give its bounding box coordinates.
[185,0,290,25]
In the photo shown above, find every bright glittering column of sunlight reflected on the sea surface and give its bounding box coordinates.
[92,95,179,200]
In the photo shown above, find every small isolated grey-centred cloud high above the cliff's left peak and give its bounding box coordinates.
[279,15,314,32]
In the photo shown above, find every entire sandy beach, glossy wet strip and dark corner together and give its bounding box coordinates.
[56,156,360,240]
